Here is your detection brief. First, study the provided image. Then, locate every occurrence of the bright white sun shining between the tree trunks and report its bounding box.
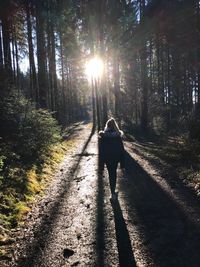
[86,57,103,79]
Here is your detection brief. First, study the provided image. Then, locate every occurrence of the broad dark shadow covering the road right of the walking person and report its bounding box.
[120,153,200,267]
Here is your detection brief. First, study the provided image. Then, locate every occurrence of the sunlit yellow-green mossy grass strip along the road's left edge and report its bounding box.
[0,129,75,265]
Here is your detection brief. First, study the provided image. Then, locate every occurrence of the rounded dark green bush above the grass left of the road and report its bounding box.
[0,92,60,160]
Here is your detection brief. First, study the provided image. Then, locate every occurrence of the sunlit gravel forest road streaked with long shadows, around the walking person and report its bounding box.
[10,124,200,267]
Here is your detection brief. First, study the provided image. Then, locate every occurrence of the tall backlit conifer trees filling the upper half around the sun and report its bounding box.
[0,0,200,137]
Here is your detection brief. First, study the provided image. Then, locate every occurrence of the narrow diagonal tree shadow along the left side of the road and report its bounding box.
[17,126,94,267]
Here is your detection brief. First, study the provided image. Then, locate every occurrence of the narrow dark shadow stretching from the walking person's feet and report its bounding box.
[111,200,136,267]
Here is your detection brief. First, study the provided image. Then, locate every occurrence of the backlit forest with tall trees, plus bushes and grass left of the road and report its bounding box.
[0,0,200,241]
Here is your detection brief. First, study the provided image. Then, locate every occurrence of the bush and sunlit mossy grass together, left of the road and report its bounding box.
[0,91,76,258]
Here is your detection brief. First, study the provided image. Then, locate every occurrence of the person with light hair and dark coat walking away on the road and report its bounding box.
[99,118,124,200]
